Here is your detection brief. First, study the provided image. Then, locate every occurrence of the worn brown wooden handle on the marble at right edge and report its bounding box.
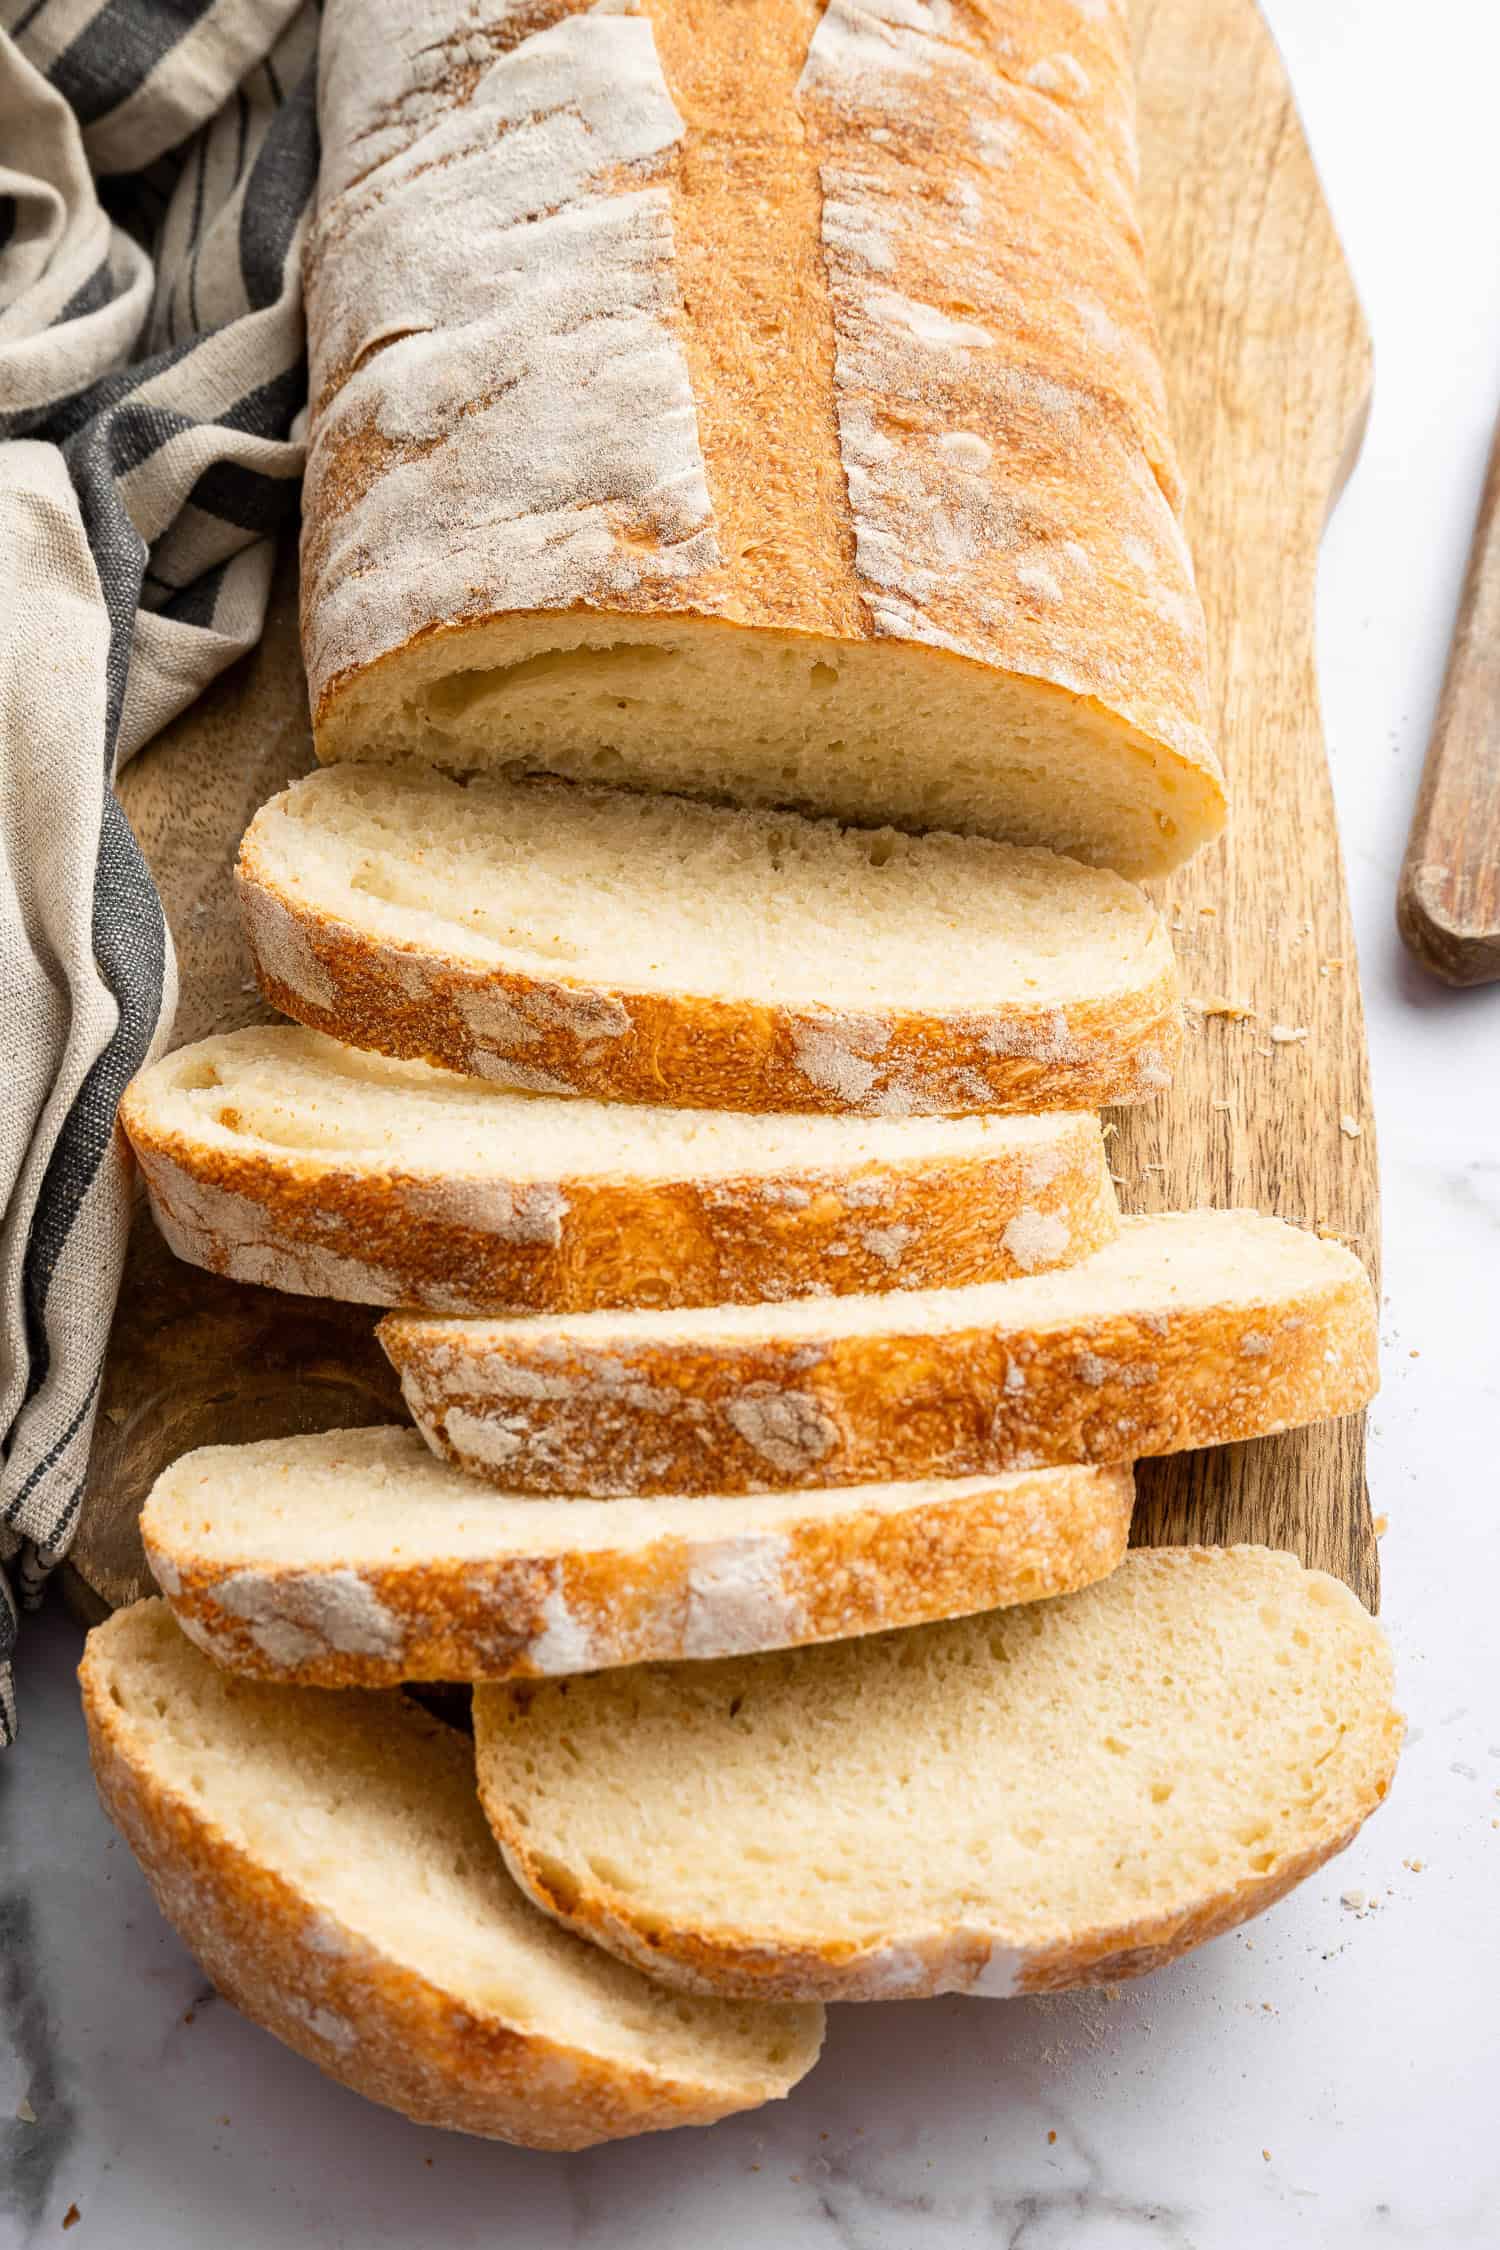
[1397,411,1500,986]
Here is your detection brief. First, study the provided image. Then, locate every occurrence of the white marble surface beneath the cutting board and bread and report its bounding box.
[0,0,1500,2250]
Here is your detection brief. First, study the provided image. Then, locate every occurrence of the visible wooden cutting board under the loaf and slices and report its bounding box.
[70,0,1379,1613]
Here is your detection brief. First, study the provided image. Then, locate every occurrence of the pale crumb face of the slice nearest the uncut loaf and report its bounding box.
[245,765,1172,1017]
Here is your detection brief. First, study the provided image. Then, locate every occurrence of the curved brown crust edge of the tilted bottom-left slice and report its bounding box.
[79,1647,823,2149]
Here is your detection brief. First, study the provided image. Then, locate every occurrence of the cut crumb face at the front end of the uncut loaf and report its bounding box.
[315,610,1226,880]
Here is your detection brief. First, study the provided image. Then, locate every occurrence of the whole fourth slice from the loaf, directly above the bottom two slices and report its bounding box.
[142,1429,1133,1688]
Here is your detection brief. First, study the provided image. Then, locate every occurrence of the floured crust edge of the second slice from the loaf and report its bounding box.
[121,1091,1120,1314]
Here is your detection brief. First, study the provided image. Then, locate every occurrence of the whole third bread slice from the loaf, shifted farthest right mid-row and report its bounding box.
[378,1211,1376,1496]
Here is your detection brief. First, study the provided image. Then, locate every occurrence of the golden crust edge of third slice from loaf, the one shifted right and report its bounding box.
[378,1260,1376,1496]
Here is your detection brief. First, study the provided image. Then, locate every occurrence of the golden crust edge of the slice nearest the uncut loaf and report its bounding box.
[236,850,1183,1116]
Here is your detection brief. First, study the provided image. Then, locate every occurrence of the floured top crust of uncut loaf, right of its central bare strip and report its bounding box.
[798,0,1212,765]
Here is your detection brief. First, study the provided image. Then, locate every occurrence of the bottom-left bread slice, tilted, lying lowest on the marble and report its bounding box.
[79,1602,823,2149]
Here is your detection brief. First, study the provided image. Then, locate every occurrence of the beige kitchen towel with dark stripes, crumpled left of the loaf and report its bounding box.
[0,0,317,1742]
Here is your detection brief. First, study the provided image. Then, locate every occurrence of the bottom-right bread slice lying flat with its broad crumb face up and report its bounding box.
[475,1548,1401,2000]
